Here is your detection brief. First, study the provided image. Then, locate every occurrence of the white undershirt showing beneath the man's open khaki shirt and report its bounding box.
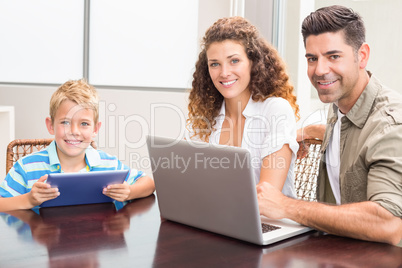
[325,109,345,205]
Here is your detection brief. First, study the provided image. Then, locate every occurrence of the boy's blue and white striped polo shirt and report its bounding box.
[0,141,145,197]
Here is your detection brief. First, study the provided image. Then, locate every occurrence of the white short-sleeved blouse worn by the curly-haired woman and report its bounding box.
[188,97,299,198]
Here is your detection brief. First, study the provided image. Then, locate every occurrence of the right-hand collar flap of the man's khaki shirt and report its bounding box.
[346,75,381,128]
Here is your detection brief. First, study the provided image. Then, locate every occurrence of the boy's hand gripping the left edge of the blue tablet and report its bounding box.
[28,175,60,207]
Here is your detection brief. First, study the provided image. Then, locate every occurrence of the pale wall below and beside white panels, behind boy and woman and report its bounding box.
[0,0,230,178]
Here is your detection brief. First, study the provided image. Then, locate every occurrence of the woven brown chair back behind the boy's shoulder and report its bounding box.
[6,139,53,174]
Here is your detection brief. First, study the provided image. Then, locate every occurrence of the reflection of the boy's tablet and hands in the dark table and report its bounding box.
[38,203,125,255]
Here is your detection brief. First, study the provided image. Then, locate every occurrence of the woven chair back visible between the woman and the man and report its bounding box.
[294,139,322,201]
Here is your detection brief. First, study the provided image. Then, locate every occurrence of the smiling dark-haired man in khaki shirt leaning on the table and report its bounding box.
[257,6,402,245]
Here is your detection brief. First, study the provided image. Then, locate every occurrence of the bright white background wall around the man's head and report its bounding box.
[283,0,402,130]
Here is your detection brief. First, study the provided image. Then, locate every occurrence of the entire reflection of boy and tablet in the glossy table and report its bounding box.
[3,196,155,267]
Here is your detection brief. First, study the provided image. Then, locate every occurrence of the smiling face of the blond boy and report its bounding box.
[46,100,100,161]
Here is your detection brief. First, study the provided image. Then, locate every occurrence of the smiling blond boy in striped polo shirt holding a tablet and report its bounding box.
[0,79,155,212]
